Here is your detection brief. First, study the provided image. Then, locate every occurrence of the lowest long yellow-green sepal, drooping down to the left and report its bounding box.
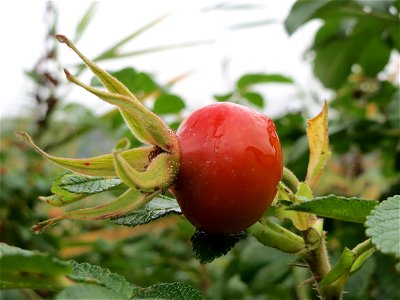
[31,189,158,233]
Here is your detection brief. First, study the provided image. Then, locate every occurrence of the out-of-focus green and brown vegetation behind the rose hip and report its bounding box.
[0,0,400,299]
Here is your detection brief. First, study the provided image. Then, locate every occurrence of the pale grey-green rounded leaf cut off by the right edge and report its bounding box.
[365,195,400,258]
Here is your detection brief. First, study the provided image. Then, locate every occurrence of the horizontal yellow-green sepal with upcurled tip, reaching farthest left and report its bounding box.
[17,131,153,177]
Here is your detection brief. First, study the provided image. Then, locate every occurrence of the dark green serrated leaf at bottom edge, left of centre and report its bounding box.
[133,282,204,300]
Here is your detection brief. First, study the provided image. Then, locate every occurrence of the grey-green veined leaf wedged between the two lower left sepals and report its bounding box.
[52,173,122,194]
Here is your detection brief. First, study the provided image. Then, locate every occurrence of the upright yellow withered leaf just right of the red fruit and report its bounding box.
[306,101,331,189]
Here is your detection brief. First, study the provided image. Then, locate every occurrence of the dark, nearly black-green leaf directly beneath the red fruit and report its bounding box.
[190,230,246,264]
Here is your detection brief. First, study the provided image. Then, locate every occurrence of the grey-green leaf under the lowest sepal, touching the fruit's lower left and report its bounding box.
[111,195,182,227]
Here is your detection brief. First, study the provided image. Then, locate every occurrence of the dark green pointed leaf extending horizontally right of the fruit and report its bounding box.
[287,195,378,223]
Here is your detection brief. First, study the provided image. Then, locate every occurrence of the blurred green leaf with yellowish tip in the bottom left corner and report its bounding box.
[0,243,72,291]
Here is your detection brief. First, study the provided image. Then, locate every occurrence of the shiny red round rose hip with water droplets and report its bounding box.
[172,102,283,234]
